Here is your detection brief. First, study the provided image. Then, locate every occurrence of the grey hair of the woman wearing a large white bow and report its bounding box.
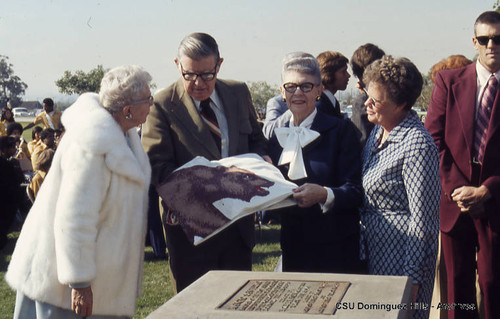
[281,52,321,85]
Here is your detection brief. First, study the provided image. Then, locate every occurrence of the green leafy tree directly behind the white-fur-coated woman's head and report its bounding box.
[56,65,108,94]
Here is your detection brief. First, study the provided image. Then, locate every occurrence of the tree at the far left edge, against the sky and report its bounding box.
[0,55,28,108]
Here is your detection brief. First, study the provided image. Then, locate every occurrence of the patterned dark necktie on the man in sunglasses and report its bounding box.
[474,75,498,164]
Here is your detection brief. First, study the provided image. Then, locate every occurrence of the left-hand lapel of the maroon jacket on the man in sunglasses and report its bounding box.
[451,63,477,154]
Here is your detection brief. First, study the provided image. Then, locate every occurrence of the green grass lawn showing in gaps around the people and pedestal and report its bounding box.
[0,226,281,319]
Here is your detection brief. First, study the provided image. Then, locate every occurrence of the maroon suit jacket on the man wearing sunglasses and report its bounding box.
[425,63,500,232]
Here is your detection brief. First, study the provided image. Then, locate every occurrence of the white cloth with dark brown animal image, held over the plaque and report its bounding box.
[158,154,296,245]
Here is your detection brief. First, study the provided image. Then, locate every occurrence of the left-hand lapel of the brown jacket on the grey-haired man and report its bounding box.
[169,79,221,159]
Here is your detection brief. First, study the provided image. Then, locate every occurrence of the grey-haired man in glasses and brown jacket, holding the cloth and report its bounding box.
[142,33,270,292]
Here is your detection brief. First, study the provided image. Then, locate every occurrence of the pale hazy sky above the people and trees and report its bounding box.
[0,0,494,101]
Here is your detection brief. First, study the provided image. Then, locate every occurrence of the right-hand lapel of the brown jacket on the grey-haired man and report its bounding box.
[214,80,242,156]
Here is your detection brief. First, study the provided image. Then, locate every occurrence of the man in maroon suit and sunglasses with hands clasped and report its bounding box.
[425,11,500,319]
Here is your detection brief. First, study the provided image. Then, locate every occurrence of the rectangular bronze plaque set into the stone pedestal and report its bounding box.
[217,279,351,315]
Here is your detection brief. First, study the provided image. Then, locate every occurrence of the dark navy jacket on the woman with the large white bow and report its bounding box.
[269,110,362,270]
